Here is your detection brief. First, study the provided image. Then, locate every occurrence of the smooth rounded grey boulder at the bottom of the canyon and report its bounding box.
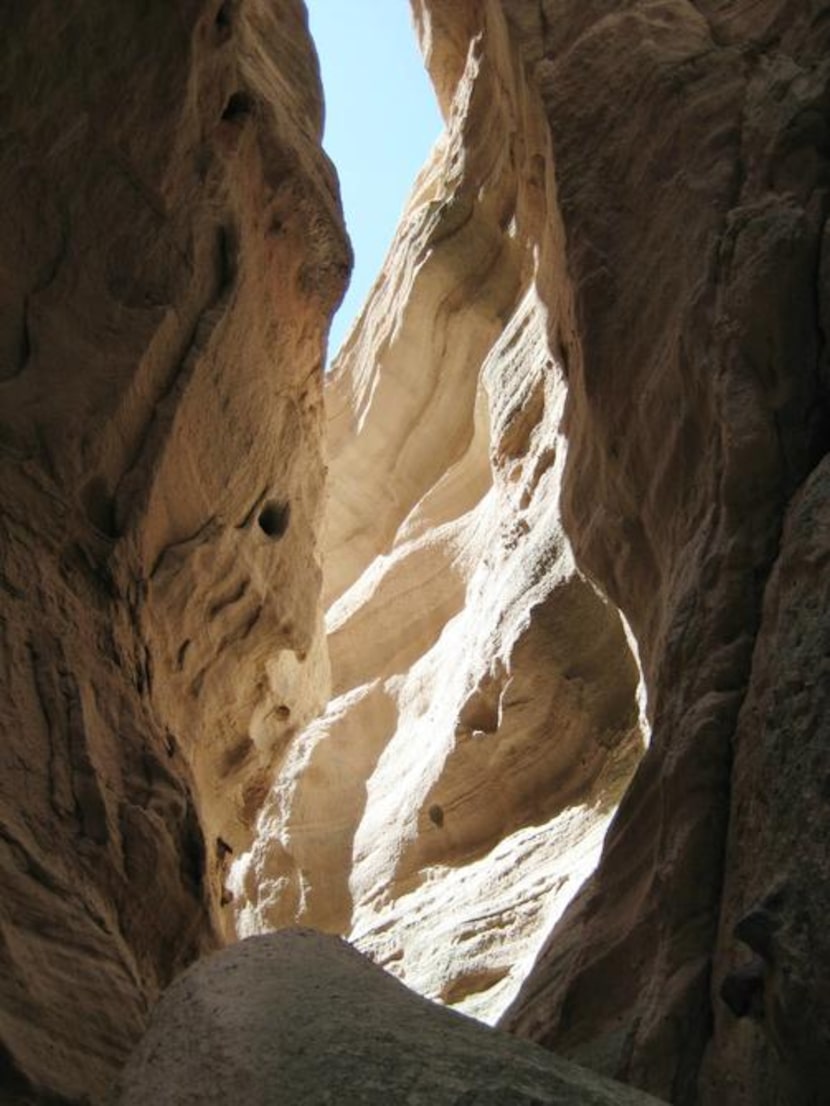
[116,930,657,1106]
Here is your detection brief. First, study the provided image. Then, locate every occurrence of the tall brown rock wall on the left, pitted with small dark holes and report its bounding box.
[0,0,349,1103]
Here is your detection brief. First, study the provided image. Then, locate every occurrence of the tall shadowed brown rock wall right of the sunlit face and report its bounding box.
[493,2,830,1104]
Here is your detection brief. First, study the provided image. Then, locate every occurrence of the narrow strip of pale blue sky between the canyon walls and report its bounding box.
[305,0,443,359]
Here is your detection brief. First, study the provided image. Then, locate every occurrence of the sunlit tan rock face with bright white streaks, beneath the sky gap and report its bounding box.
[229,4,644,1020]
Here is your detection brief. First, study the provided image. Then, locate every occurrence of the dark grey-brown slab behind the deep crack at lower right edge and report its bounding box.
[706,458,830,1106]
